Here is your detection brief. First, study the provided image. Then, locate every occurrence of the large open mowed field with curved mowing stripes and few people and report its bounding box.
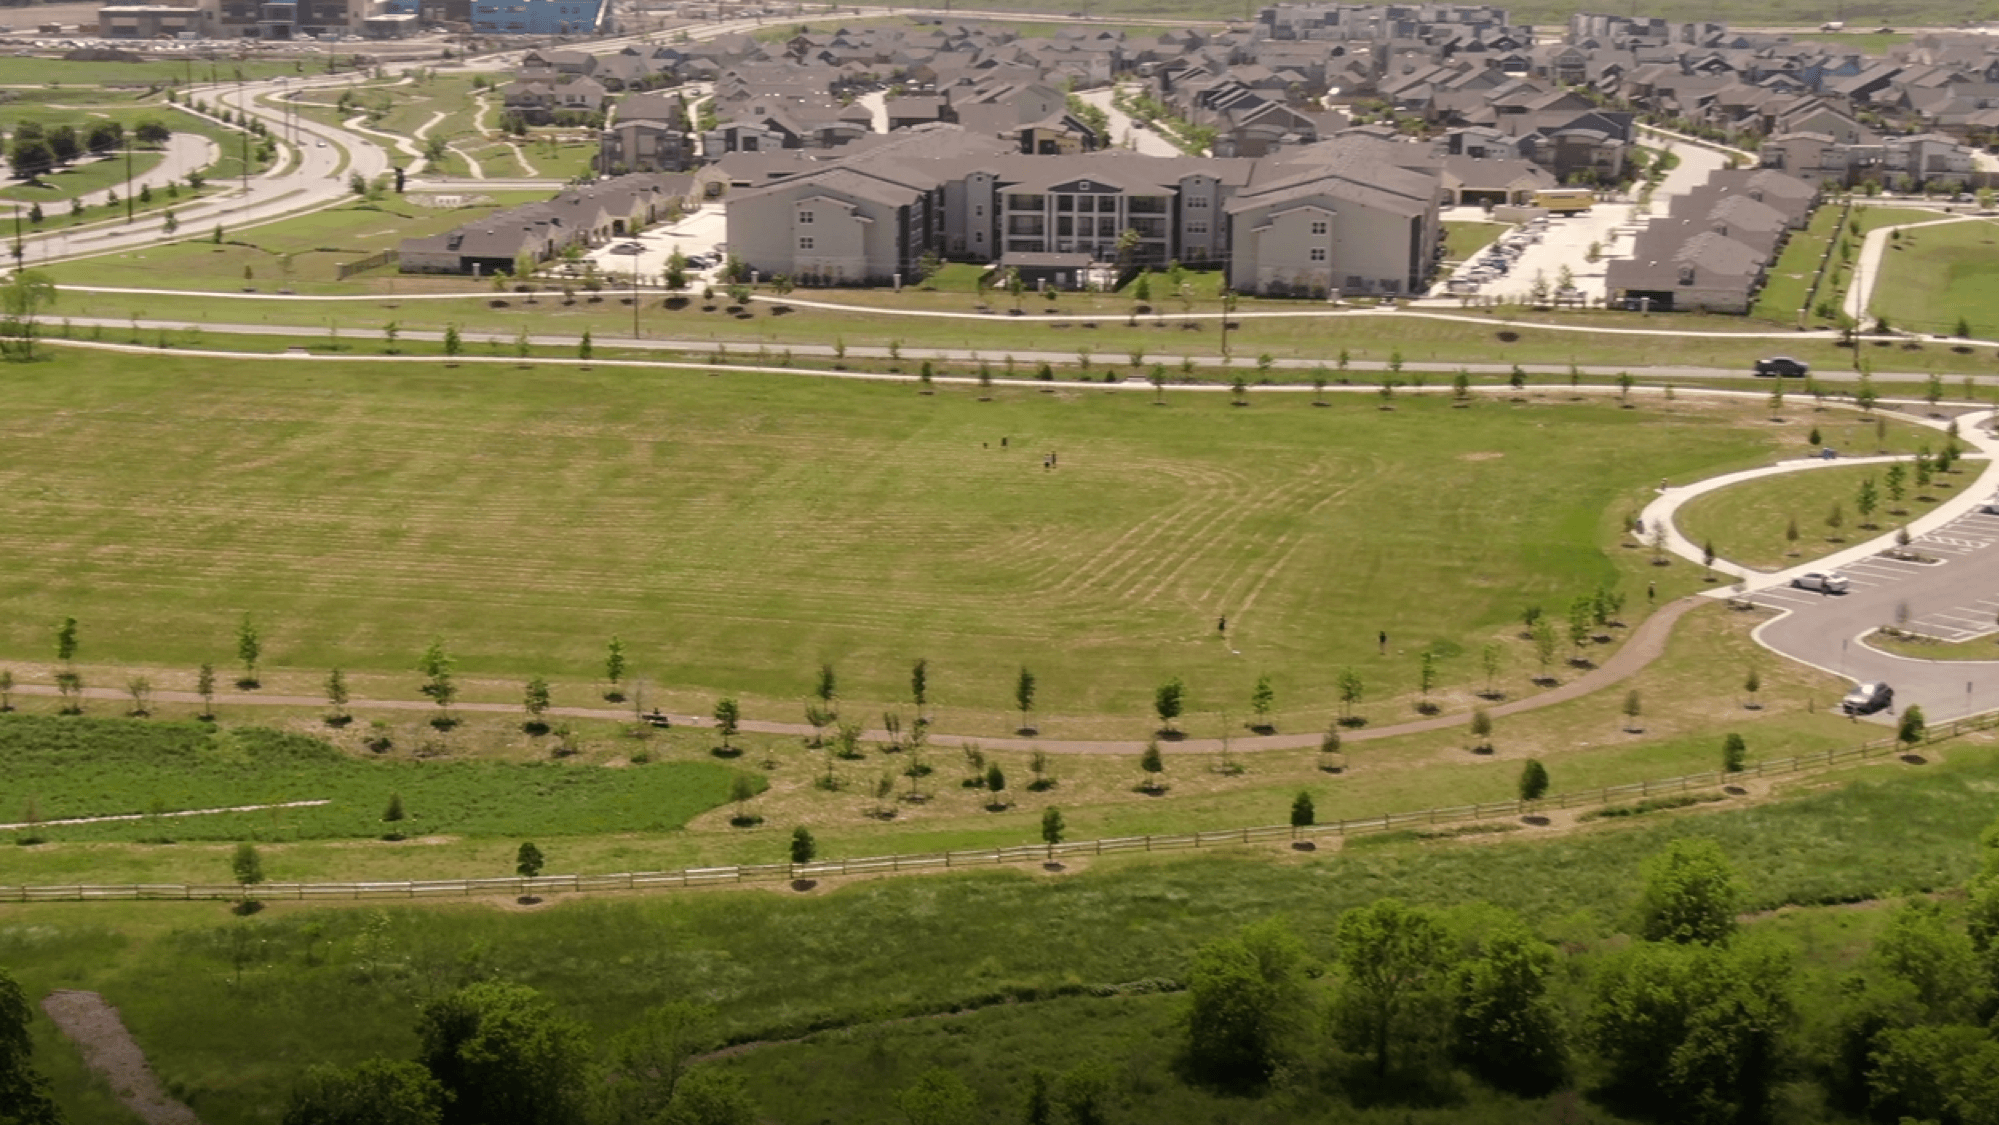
[0,348,1779,737]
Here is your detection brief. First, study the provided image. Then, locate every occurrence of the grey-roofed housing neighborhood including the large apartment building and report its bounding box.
[389,4,1999,312]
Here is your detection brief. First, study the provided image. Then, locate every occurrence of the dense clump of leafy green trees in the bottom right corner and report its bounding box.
[1185,825,1999,1125]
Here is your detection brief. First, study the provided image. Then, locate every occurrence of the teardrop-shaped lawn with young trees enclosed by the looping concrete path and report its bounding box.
[1677,451,1965,569]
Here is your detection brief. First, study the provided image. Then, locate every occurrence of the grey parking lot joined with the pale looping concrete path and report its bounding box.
[1641,405,1999,721]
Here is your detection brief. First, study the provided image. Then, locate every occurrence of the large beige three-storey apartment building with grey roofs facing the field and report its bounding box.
[728,126,1439,296]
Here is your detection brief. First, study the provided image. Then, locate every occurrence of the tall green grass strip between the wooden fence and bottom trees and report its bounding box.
[0,747,1999,1125]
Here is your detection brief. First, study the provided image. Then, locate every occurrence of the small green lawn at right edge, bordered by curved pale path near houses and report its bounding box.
[1873,220,1999,338]
